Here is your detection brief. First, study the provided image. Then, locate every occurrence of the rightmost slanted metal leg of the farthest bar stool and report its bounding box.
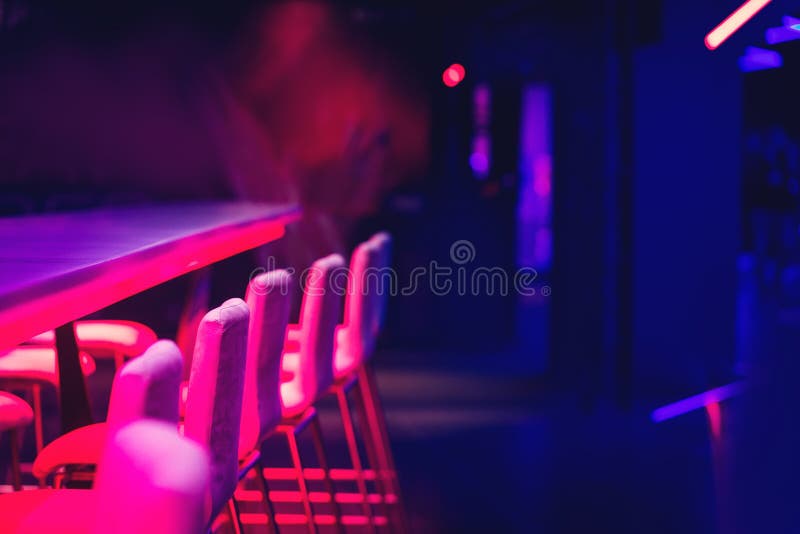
[358,363,411,532]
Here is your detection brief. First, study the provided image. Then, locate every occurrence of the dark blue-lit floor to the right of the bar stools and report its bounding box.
[370,354,716,532]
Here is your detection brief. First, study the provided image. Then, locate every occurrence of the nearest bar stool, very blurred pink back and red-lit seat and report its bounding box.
[0,420,210,534]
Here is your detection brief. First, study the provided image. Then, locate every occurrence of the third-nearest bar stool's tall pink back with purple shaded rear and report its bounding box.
[184,299,250,529]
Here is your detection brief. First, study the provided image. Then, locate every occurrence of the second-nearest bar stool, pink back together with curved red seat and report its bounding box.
[33,340,183,483]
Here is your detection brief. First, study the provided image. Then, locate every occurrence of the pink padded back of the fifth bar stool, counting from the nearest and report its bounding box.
[297,254,346,398]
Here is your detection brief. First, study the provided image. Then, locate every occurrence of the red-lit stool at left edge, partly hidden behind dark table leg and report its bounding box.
[0,346,96,453]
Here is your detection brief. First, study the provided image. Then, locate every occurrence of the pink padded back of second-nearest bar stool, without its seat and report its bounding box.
[108,340,183,429]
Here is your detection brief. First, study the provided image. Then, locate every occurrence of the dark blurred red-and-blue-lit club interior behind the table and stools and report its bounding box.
[0,0,800,533]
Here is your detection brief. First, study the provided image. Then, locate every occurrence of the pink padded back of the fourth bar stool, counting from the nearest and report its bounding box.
[239,270,292,458]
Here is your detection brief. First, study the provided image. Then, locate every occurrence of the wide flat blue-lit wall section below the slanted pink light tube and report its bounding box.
[634,0,742,398]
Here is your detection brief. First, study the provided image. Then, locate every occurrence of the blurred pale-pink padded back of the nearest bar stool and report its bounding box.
[92,420,209,534]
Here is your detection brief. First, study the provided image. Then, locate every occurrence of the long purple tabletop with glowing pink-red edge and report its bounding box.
[0,202,300,350]
